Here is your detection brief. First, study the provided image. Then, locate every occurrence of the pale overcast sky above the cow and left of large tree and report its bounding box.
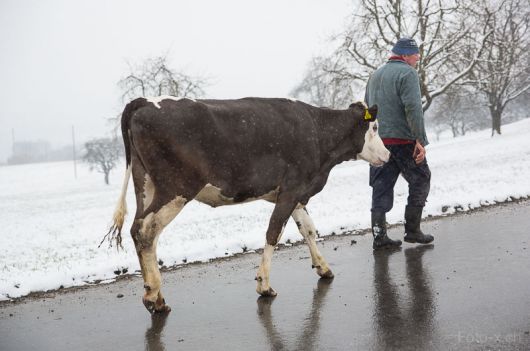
[0,0,353,162]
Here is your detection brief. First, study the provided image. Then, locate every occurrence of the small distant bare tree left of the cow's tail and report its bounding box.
[83,138,123,185]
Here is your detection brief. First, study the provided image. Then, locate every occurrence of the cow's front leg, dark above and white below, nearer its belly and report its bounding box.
[256,194,297,296]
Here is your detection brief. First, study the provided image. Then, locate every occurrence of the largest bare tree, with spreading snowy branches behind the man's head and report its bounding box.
[302,0,490,111]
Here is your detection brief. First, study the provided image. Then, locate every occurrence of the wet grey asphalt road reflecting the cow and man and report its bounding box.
[0,201,530,350]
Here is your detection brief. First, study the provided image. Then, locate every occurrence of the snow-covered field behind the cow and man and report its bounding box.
[0,119,530,300]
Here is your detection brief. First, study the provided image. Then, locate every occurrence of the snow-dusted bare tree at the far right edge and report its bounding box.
[473,0,530,136]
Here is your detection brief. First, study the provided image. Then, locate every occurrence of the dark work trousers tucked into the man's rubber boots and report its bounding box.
[370,144,431,213]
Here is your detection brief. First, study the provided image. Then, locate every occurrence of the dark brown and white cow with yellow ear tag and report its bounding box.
[106,96,389,313]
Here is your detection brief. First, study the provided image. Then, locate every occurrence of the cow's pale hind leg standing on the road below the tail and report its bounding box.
[131,195,187,313]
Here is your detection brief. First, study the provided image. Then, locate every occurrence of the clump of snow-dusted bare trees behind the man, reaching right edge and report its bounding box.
[292,0,530,135]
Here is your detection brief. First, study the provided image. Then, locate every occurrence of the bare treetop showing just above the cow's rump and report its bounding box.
[118,56,207,101]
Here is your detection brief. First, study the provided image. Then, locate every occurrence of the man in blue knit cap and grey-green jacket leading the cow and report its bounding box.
[365,38,434,250]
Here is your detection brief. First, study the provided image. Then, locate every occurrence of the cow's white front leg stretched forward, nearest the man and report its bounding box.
[292,205,333,279]
